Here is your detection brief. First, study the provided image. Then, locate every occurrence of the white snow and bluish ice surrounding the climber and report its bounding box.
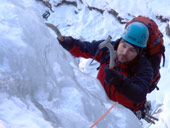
[0,0,170,128]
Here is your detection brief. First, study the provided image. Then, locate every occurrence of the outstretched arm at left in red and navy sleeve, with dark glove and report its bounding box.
[58,36,106,61]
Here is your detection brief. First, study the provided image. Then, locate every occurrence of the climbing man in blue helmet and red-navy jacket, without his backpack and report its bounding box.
[56,22,153,112]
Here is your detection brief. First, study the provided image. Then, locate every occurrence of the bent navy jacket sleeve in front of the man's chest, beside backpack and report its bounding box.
[116,55,153,103]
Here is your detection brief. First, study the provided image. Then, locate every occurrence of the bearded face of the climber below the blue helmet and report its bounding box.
[117,39,137,64]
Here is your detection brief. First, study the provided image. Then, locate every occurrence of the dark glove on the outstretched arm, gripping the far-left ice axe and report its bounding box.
[57,36,74,51]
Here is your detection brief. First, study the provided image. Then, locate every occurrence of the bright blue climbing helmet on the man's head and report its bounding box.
[122,22,149,48]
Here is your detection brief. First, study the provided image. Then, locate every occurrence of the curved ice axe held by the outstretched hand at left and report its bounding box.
[45,23,64,41]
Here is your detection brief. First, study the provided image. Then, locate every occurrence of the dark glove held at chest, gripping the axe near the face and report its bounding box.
[104,66,124,87]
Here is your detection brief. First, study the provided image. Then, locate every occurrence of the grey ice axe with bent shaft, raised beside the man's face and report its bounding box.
[90,35,116,69]
